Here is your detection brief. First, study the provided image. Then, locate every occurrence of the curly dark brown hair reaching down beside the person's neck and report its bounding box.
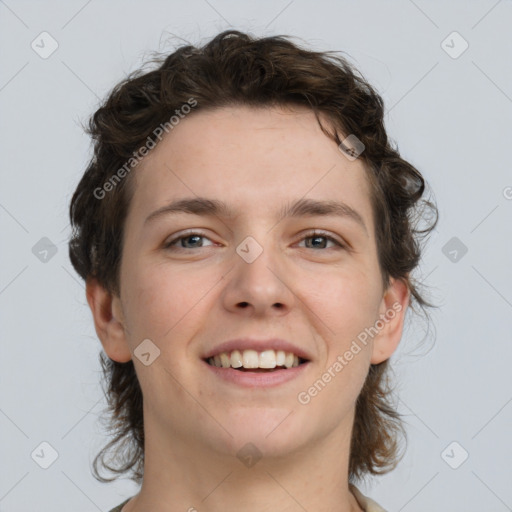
[69,30,438,483]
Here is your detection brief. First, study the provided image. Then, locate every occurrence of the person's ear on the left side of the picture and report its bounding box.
[85,278,132,363]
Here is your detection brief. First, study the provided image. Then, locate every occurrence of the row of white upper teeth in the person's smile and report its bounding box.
[208,350,299,368]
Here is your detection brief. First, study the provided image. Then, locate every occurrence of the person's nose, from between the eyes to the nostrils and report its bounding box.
[222,239,296,316]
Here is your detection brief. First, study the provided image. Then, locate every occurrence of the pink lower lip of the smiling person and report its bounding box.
[203,361,309,388]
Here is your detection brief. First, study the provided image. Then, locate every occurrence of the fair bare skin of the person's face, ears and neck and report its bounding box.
[87,106,409,512]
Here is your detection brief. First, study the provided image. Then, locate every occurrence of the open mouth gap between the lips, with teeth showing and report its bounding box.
[204,350,308,373]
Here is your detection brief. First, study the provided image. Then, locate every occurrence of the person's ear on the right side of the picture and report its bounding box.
[371,279,410,364]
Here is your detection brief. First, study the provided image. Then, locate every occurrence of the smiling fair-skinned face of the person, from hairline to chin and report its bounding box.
[94,107,406,455]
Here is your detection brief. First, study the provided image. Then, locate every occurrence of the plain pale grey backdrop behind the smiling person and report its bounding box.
[0,0,512,512]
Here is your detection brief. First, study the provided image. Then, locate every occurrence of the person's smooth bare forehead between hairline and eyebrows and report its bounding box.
[125,106,372,229]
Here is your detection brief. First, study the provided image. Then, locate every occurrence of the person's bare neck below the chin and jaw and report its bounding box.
[123,408,362,512]
